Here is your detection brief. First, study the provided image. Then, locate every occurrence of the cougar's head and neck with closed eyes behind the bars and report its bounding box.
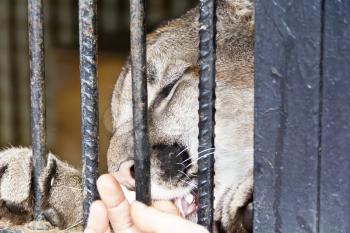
[107,0,254,232]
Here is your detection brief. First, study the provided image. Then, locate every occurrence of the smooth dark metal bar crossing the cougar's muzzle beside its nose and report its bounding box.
[130,0,151,204]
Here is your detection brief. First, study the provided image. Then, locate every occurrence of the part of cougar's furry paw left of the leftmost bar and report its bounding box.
[0,148,33,228]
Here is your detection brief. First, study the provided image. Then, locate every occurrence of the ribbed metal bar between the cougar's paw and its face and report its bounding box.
[79,0,98,227]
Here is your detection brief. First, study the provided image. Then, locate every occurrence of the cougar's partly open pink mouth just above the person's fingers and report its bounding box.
[172,190,198,220]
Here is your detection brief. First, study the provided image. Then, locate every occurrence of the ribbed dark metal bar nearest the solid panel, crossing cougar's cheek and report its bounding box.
[198,0,216,231]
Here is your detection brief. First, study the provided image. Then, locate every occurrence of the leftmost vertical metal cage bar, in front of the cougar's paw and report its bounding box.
[28,0,46,220]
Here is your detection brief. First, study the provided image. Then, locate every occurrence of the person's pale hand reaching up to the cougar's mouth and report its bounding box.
[85,174,208,233]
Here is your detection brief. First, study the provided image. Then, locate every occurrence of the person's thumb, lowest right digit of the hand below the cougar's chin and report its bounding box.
[131,201,208,233]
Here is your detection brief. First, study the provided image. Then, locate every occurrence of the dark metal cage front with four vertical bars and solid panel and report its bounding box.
[1,0,350,233]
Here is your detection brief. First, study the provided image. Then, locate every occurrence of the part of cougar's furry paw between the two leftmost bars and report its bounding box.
[40,154,83,229]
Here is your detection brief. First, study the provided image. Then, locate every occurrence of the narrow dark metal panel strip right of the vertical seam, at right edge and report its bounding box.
[320,1,350,233]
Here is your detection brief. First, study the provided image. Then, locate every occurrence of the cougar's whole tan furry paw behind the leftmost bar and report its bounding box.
[0,148,82,229]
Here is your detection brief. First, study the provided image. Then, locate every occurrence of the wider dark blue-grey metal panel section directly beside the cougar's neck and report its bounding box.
[254,0,322,233]
